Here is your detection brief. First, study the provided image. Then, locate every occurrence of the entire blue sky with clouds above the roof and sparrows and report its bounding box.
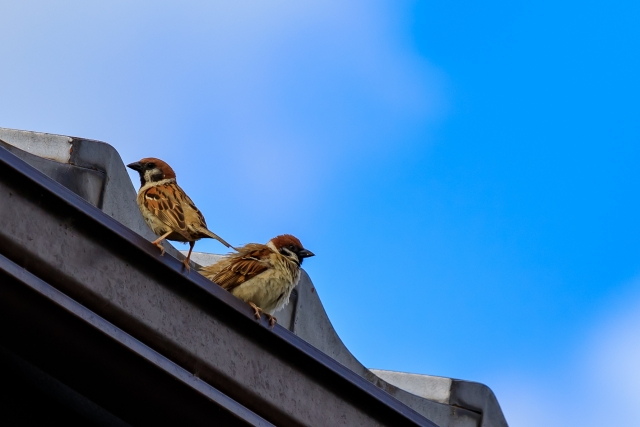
[0,0,640,427]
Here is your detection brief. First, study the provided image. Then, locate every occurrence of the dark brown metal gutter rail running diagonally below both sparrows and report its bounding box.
[0,143,436,427]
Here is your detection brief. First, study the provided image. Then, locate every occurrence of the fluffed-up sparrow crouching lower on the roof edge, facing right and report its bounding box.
[200,234,314,327]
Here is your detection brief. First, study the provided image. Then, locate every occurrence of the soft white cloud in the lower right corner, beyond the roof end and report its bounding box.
[494,279,640,427]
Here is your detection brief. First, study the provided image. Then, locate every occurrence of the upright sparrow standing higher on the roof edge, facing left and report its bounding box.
[127,157,234,272]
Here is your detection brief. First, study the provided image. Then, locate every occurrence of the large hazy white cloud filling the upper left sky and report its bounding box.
[0,0,444,217]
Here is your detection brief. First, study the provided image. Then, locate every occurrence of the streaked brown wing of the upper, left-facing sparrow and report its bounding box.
[144,184,187,234]
